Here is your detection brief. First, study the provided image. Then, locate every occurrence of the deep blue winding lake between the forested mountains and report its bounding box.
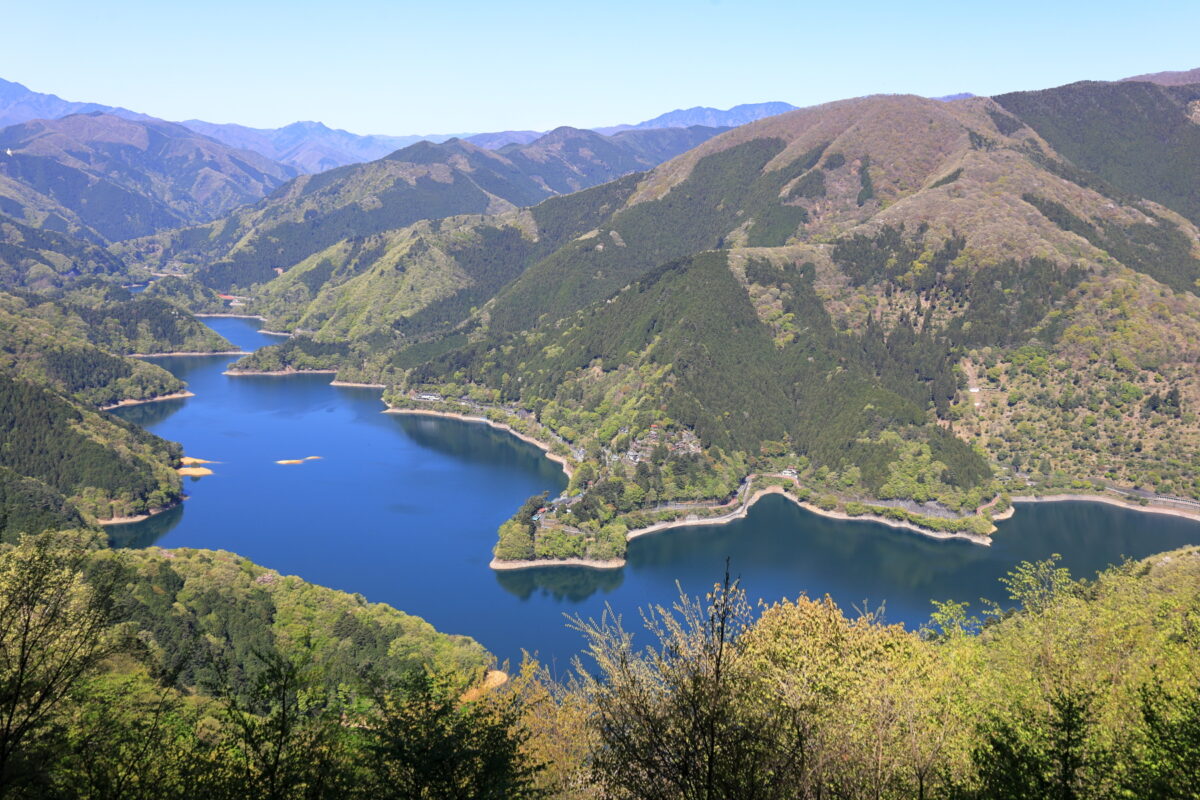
[109,318,1200,670]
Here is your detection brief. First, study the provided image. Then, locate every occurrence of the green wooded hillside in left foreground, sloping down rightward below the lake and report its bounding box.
[0,527,496,800]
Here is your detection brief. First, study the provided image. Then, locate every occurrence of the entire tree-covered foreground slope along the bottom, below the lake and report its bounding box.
[0,534,1200,800]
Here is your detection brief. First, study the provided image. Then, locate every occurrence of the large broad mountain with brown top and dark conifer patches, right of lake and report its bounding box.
[223,84,1200,558]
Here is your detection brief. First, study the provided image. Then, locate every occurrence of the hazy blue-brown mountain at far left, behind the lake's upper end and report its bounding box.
[0,112,295,242]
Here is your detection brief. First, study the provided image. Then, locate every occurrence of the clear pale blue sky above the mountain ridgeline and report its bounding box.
[0,0,1200,134]
